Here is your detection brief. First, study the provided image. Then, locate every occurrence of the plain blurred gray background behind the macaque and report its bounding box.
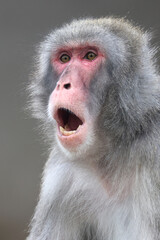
[0,0,160,240]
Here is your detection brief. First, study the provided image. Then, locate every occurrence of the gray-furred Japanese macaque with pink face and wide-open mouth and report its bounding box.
[27,18,160,240]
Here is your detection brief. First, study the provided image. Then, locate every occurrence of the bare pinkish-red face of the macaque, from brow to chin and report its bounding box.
[49,46,105,149]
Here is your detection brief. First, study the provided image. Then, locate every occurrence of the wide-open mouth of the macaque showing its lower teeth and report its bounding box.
[57,108,83,136]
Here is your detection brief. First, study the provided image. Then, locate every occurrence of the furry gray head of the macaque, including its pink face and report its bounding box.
[31,18,155,152]
